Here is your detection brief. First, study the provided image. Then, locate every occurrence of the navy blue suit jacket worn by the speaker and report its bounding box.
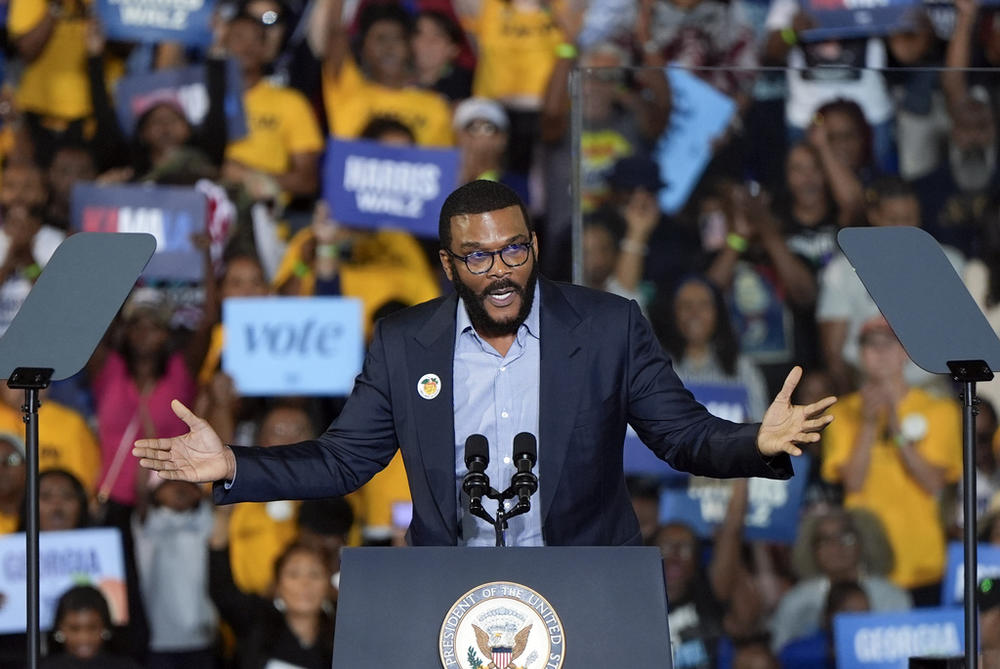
[215,278,792,546]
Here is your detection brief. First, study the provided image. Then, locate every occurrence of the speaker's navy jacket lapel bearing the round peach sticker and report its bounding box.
[406,293,458,544]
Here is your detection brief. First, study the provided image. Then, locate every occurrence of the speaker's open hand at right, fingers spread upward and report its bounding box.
[757,366,837,456]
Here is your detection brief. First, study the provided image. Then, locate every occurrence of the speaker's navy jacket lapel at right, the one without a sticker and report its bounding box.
[538,278,587,527]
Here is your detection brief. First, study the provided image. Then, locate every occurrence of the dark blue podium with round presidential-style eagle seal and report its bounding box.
[333,546,671,669]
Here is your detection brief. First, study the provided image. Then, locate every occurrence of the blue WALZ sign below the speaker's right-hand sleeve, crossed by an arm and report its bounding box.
[660,455,810,544]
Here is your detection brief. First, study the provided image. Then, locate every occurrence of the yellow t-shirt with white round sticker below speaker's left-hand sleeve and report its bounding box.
[229,502,299,596]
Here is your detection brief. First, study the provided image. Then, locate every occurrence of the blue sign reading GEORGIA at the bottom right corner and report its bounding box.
[833,608,965,669]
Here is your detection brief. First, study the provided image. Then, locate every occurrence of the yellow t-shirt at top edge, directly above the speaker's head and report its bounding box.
[466,0,566,107]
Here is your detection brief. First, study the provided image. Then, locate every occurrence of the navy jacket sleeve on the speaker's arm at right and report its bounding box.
[626,302,792,479]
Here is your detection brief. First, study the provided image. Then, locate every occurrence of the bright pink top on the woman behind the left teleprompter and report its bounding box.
[93,352,197,505]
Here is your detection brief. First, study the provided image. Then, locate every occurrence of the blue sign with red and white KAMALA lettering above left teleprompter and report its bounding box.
[70,182,208,281]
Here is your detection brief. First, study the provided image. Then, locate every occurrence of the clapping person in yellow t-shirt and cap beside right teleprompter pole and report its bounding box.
[823,316,962,606]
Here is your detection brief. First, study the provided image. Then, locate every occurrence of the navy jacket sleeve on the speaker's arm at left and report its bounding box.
[214,324,399,504]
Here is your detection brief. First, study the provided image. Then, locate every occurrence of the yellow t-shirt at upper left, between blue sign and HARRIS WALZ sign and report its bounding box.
[226,79,323,174]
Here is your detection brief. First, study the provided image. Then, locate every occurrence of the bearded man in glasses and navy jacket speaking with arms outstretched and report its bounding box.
[133,181,835,546]
